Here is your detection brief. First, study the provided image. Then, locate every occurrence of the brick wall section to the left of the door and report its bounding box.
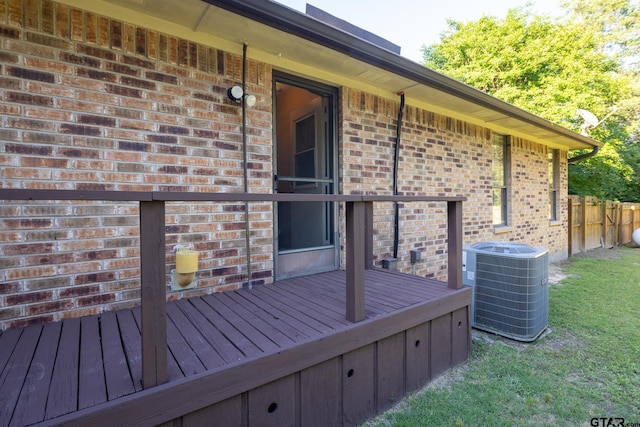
[0,0,273,329]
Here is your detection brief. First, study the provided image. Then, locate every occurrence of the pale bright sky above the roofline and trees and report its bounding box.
[274,0,560,62]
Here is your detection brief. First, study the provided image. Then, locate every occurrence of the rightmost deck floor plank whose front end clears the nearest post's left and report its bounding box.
[100,312,135,400]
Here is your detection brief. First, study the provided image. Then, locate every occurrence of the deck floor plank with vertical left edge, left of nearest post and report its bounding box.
[78,316,107,409]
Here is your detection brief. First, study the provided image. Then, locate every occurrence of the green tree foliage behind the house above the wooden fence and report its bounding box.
[423,0,640,201]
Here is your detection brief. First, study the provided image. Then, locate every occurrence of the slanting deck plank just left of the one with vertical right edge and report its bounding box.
[10,322,62,426]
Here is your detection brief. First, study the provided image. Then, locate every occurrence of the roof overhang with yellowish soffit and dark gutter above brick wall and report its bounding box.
[58,0,602,150]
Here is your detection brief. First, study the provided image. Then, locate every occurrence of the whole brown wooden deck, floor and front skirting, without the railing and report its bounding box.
[0,269,471,426]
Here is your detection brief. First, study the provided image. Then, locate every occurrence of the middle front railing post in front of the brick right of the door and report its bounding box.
[345,202,370,323]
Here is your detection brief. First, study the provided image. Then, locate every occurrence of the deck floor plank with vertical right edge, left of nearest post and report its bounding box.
[46,318,80,418]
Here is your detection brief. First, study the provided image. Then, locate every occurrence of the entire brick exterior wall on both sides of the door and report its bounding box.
[0,0,567,329]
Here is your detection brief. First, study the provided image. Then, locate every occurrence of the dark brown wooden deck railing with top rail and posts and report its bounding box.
[0,189,465,388]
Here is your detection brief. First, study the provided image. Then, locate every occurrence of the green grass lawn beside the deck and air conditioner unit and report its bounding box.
[366,247,640,426]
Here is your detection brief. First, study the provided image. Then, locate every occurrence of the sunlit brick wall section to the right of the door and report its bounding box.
[340,89,567,280]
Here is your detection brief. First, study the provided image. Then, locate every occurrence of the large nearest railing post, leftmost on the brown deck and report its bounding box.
[140,201,169,388]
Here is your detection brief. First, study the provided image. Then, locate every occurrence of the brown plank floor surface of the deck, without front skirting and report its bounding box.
[0,270,470,427]
